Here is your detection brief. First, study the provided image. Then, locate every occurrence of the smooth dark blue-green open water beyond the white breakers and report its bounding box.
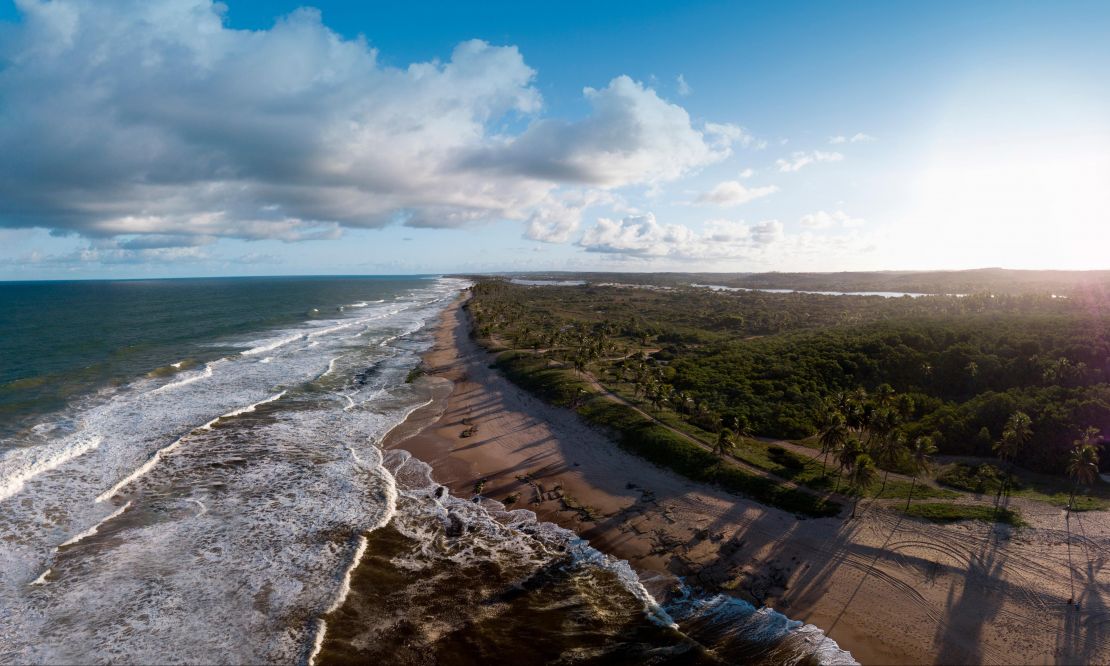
[0,276,428,438]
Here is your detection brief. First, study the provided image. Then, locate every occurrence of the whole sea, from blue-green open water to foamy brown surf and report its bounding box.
[0,276,852,664]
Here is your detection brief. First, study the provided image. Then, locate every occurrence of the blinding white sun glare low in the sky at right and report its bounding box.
[904,127,1110,269]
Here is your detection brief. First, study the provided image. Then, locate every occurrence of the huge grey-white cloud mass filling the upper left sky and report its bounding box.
[0,0,744,246]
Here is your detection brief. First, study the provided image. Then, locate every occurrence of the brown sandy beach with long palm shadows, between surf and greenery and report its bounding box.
[375,303,1110,664]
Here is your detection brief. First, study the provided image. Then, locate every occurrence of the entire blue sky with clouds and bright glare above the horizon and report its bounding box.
[0,0,1110,280]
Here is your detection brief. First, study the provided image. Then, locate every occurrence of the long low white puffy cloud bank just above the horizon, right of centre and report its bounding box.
[578,213,783,261]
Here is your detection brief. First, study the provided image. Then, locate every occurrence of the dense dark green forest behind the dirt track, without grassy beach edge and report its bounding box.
[474,280,1110,474]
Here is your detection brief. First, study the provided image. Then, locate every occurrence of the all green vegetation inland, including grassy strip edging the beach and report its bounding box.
[470,276,1110,523]
